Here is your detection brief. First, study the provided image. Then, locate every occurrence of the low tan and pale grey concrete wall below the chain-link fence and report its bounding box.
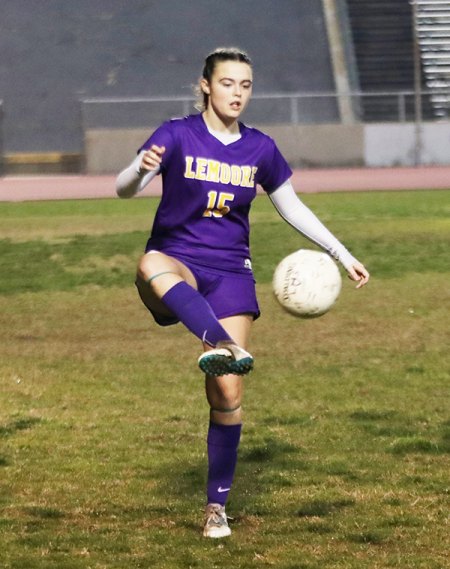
[85,122,450,174]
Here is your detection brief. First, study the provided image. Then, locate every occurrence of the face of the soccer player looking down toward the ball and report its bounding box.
[202,61,253,124]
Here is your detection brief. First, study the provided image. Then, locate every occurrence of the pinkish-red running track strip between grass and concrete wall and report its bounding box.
[0,166,450,202]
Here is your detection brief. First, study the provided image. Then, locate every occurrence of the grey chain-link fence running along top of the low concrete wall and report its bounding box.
[81,89,450,130]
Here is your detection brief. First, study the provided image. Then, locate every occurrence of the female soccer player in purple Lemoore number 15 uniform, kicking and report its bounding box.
[117,48,369,538]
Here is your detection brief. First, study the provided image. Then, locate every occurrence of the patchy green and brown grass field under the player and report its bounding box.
[0,191,450,569]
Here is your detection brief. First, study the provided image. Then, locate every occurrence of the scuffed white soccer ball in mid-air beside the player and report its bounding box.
[273,249,342,318]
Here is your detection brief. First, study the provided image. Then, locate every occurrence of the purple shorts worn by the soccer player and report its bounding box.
[136,259,261,326]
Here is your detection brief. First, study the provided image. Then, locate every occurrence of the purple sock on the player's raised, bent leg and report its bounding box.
[161,281,232,347]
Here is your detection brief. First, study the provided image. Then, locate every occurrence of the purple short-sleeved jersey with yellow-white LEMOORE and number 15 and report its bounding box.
[140,114,292,276]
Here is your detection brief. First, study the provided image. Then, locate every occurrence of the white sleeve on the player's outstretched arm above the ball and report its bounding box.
[269,180,356,269]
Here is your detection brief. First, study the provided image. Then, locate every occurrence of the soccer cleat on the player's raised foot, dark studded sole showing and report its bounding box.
[198,342,253,376]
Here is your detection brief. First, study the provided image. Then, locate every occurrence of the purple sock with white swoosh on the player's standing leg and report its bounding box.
[207,422,242,506]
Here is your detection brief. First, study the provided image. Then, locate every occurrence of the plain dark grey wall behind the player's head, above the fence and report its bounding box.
[0,0,334,153]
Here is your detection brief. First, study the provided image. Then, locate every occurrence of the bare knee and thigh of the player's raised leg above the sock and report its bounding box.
[136,251,197,316]
